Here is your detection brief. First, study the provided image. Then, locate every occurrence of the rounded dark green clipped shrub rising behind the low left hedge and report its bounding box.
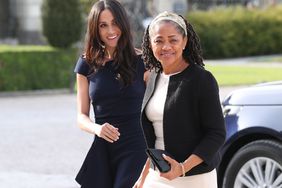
[42,0,83,48]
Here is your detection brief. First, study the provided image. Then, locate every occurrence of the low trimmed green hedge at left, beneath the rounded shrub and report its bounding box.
[0,47,77,91]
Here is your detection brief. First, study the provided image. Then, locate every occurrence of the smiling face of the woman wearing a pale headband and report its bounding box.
[150,21,187,72]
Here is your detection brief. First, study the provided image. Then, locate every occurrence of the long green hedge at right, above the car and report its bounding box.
[187,6,282,59]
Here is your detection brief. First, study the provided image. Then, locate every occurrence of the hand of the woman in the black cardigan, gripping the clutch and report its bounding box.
[160,154,182,180]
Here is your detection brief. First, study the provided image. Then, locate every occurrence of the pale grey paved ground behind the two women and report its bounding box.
[0,87,242,188]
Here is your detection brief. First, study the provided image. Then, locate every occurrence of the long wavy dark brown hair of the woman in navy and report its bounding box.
[84,0,136,85]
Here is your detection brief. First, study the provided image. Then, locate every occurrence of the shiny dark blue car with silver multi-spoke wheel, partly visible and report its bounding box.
[218,81,282,188]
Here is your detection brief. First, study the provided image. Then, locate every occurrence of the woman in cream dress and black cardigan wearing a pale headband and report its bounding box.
[134,12,226,188]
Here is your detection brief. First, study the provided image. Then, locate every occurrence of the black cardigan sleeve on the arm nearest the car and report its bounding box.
[193,71,226,164]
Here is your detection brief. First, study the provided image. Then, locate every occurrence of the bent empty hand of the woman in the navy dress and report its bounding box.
[94,123,120,143]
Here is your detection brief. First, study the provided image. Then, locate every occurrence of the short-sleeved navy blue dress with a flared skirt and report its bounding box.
[74,56,147,188]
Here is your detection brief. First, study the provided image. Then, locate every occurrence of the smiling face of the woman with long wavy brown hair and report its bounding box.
[98,9,121,54]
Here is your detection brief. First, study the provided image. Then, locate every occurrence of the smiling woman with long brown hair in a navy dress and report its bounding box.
[72,0,146,188]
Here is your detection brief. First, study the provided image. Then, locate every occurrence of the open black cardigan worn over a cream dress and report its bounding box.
[141,64,226,176]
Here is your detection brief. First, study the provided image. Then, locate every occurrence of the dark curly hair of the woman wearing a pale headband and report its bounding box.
[142,15,205,72]
